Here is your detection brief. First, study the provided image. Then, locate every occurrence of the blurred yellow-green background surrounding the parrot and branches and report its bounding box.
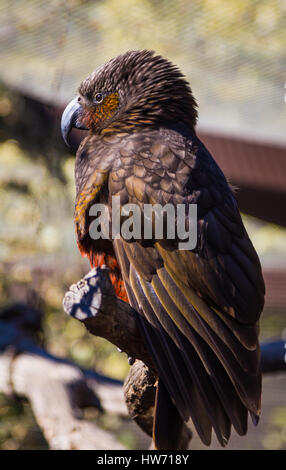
[0,0,286,449]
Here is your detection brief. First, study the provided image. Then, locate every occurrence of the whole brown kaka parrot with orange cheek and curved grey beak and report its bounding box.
[61,51,265,449]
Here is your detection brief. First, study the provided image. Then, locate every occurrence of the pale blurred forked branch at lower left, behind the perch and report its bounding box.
[0,305,126,450]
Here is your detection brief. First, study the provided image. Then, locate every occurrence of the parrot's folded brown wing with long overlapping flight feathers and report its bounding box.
[107,129,265,445]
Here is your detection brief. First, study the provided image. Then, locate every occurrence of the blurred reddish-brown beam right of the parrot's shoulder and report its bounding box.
[199,132,286,227]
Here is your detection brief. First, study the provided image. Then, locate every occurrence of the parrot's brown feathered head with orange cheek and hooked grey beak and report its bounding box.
[62,51,197,143]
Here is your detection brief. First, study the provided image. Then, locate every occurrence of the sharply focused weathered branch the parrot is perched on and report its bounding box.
[63,268,285,449]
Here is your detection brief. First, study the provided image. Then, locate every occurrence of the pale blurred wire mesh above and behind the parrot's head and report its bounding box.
[0,0,286,143]
